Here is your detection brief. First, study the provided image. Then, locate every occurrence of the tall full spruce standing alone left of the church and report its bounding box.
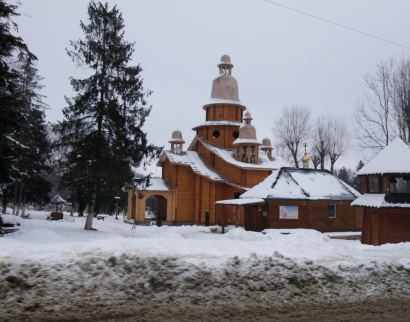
[54,1,160,229]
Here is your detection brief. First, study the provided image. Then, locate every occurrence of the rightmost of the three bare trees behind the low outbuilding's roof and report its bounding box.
[327,116,350,173]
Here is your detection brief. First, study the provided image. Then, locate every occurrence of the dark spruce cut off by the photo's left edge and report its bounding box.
[0,0,41,211]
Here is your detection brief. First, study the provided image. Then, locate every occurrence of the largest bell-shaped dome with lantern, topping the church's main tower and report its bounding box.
[211,55,240,103]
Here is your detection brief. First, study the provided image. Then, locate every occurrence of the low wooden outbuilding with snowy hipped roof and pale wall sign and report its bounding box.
[229,167,362,232]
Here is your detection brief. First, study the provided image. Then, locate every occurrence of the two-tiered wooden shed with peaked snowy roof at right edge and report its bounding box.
[352,138,410,246]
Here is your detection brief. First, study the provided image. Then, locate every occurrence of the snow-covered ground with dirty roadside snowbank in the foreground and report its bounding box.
[0,211,410,321]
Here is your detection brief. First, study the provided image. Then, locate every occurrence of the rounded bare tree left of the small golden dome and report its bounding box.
[272,105,311,168]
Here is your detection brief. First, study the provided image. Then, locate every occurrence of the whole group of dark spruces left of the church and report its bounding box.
[0,0,161,229]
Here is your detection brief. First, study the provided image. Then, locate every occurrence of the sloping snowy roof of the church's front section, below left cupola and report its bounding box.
[157,150,249,190]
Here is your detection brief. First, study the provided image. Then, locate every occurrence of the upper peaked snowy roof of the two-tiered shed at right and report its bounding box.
[357,137,410,175]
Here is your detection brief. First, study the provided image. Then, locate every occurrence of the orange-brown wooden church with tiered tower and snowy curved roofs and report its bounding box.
[126,55,289,225]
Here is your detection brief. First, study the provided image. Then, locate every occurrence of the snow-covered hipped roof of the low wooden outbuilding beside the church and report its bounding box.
[240,168,360,200]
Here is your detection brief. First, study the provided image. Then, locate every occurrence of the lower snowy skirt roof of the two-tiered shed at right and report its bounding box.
[351,193,410,208]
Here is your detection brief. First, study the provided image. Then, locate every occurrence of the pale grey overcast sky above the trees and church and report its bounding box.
[13,0,410,174]
